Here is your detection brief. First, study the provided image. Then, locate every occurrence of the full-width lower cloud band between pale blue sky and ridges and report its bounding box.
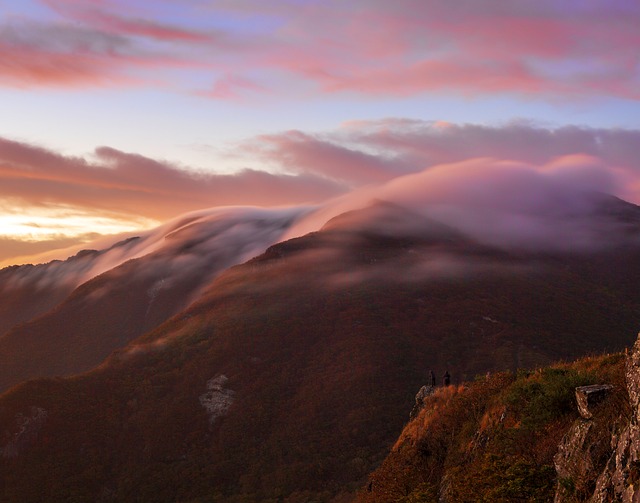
[8,119,640,219]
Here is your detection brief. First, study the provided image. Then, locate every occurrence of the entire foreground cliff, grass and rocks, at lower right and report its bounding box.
[357,338,640,503]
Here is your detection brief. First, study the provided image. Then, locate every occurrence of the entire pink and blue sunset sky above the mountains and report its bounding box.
[0,0,640,265]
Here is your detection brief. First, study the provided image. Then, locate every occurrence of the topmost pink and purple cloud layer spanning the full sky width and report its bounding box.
[0,0,640,100]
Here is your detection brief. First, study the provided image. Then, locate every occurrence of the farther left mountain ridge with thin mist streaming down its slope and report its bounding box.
[0,208,306,390]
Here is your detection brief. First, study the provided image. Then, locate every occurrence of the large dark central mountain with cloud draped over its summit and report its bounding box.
[0,198,640,502]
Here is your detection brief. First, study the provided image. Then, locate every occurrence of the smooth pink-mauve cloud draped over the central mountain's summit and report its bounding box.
[289,156,637,251]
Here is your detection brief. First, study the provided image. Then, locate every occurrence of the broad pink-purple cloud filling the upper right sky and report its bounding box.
[190,0,640,99]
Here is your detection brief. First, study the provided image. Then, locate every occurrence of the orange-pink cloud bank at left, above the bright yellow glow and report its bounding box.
[0,139,345,219]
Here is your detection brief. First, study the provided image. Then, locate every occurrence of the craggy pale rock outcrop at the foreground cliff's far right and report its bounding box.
[554,336,640,503]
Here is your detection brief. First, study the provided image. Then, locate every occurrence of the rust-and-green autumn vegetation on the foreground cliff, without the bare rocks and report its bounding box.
[358,354,629,503]
